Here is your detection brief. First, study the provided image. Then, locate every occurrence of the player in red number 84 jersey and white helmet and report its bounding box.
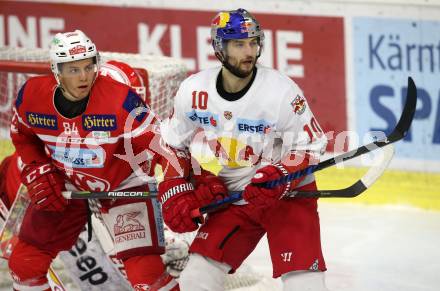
[9,30,186,290]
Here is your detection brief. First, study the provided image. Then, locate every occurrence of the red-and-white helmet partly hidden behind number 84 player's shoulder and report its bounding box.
[99,61,147,102]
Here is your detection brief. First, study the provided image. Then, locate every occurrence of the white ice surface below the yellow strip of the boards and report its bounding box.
[0,202,440,291]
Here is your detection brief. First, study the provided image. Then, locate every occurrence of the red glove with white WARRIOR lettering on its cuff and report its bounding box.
[159,178,200,233]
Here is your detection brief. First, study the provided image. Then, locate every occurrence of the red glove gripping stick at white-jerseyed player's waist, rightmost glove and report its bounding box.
[243,164,290,210]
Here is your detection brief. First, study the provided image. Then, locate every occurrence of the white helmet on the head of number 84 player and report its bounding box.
[49,29,99,76]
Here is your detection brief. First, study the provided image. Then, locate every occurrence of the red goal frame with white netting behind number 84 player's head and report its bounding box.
[0,47,188,141]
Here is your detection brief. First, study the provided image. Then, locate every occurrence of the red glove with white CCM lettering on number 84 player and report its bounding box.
[21,163,68,211]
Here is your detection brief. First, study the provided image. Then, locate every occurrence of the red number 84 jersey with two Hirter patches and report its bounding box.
[11,76,160,191]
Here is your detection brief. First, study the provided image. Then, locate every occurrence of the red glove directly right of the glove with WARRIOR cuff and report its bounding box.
[193,170,228,207]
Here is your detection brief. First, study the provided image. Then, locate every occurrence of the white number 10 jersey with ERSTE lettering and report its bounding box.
[161,65,327,191]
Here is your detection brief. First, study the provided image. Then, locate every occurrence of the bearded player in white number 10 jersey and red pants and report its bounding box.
[159,9,327,291]
